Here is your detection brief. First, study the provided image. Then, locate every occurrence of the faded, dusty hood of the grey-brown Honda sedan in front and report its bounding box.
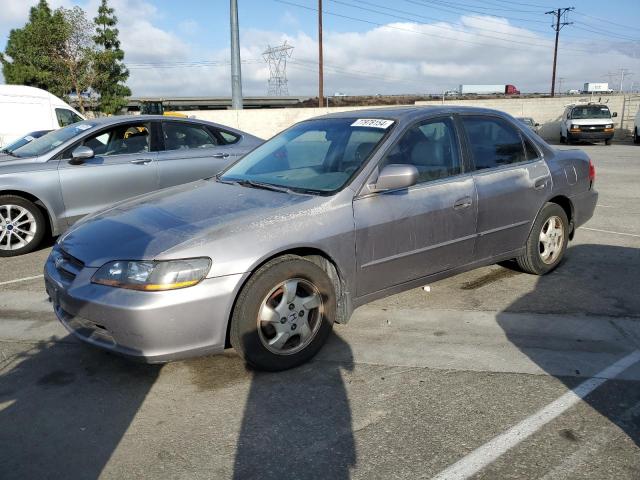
[59,180,327,267]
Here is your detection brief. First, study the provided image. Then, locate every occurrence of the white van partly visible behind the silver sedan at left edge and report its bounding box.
[0,85,85,148]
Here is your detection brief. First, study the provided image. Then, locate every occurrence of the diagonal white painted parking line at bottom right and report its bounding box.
[433,350,640,480]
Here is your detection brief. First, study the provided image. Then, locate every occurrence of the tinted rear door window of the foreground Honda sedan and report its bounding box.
[461,116,527,170]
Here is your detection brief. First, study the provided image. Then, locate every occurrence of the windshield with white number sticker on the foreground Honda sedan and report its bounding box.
[219,118,393,193]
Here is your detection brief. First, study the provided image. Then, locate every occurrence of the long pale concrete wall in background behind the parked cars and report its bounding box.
[182,95,631,141]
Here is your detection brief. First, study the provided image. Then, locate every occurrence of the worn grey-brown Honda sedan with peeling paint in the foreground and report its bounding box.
[45,107,597,370]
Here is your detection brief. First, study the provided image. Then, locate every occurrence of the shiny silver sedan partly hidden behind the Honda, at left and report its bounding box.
[0,115,262,257]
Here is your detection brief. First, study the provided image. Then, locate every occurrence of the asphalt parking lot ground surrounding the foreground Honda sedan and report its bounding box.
[0,144,640,480]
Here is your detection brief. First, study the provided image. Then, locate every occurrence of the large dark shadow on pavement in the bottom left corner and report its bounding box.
[0,336,161,480]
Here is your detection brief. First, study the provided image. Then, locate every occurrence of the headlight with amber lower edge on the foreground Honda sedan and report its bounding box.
[91,258,211,292]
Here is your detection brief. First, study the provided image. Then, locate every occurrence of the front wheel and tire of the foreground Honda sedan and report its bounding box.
[230,255,336,371]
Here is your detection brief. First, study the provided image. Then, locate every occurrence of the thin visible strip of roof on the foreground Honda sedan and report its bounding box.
[315,105,507,122]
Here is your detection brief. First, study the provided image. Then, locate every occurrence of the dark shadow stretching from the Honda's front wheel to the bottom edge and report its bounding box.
[233,333,356,480]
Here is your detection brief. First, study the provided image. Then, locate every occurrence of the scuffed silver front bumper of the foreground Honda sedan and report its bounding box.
[44,253,244,363]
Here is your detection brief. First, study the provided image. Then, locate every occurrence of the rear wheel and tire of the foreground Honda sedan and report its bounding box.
[516,203,569,275]
